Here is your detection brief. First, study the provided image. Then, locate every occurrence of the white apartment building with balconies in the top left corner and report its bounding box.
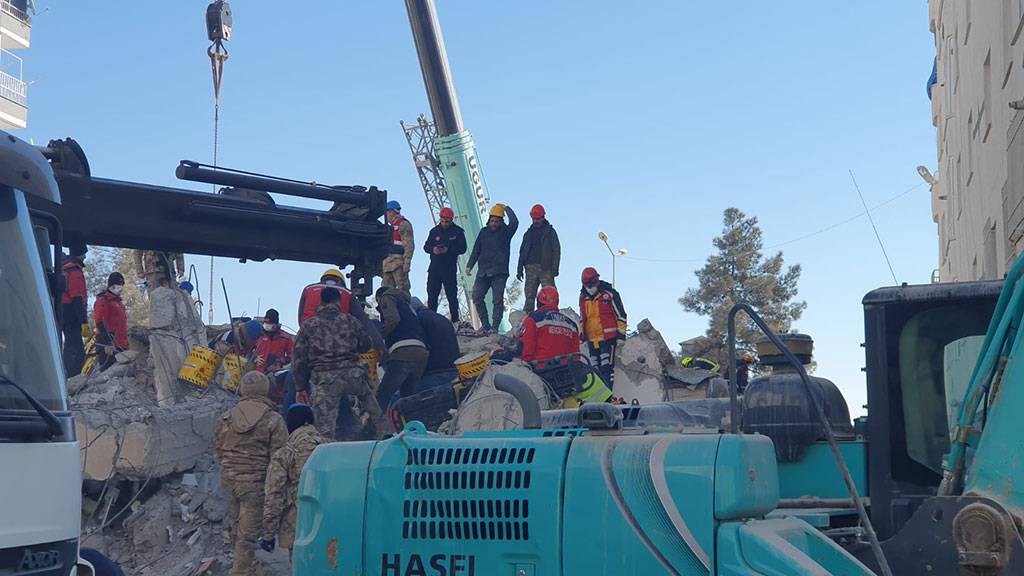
[0,0,32,130]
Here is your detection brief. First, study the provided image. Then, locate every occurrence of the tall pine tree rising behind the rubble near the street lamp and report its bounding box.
[679,208,807,366]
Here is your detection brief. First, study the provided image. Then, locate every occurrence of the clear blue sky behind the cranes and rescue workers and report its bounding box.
[19,0,937,412]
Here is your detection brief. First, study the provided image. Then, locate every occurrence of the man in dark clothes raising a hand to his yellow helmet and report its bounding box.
[466,204,519,333]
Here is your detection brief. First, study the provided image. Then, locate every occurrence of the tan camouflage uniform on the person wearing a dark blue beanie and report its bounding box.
[263,424,327,549]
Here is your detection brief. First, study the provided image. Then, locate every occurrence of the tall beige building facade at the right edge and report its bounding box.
[928,0,1024,282]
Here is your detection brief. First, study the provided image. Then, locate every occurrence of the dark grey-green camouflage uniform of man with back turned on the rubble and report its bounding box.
[292,304,381,439]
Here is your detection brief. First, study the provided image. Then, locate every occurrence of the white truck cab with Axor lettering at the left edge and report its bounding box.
[0,132,86,576]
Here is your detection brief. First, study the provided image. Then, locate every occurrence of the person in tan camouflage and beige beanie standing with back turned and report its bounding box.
[213,370,288,576]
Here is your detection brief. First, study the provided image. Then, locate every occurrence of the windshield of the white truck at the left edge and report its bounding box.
[0,188,68,411]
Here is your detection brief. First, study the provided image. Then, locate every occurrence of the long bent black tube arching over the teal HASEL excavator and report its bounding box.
[728,303,893,576]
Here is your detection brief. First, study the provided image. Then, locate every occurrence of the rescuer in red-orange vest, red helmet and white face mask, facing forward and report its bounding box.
[580,268,626,387]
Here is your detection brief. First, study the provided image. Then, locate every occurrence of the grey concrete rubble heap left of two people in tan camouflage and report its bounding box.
[69,328,291,576]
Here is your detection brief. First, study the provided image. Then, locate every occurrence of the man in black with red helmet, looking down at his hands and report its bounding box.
[423,206,466,324]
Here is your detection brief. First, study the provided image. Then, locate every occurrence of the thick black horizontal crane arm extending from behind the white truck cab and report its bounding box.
[24,138,390,294]
